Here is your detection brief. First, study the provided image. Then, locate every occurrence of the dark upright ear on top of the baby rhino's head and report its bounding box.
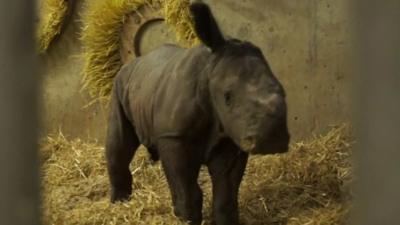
[190,1,225,51]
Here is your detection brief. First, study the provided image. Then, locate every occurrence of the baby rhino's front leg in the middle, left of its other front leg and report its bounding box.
[159,140,203,225]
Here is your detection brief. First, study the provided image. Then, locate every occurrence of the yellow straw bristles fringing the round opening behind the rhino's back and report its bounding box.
[81,0,195,100]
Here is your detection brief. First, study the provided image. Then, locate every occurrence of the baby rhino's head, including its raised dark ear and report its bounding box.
[190,2,290,154]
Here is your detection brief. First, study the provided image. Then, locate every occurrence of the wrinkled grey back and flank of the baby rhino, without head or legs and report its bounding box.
[123,45,208,146]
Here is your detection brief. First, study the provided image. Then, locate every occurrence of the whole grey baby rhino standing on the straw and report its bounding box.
[106,3,289,225]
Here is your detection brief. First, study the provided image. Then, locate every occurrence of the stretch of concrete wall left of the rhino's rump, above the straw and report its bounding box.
[42,1,107,139]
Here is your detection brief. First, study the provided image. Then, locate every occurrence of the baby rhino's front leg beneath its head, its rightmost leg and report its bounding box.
[207,139,248,225]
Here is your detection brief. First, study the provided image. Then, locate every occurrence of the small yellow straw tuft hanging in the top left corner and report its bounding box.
[36,0,68,53]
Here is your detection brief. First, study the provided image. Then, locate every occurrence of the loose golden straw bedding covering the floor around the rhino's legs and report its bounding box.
[42,126,353,225]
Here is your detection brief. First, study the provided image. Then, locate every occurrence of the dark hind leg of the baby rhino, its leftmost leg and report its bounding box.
[106,91,139,202]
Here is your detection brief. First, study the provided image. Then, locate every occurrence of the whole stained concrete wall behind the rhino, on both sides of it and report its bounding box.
[44,0,351,139]
